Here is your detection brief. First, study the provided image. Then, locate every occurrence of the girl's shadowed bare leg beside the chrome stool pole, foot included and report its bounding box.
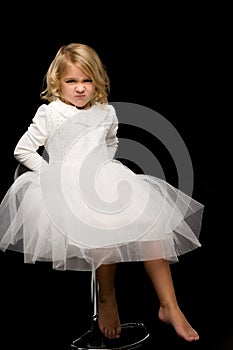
[96,264,121,339]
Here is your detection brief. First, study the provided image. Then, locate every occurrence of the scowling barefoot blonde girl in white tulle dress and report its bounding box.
[0,43,203,341]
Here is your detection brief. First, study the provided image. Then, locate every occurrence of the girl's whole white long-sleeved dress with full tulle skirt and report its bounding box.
[0,100,203,270]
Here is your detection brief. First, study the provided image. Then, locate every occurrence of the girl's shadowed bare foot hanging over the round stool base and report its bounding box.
[98,296,121,339]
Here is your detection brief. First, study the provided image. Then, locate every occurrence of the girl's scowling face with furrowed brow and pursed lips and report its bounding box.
[61,63,95,109]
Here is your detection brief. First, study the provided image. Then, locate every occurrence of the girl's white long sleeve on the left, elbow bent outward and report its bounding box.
[14,104,48,171]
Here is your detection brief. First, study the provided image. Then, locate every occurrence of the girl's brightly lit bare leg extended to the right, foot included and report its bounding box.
[144,259,199,341]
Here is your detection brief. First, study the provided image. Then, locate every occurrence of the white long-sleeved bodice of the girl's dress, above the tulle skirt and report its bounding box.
[14,100,118,171]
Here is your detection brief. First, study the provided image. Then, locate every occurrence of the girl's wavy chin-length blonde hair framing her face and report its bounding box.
[40,43,110,104]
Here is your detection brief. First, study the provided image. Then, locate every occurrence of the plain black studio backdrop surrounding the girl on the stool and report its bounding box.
[0,2,229,350]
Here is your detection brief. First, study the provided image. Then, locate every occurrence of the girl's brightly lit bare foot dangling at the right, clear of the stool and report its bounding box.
[158,305,199,342]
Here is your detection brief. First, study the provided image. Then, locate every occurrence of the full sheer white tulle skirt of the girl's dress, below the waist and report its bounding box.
[0,160,204,271]
